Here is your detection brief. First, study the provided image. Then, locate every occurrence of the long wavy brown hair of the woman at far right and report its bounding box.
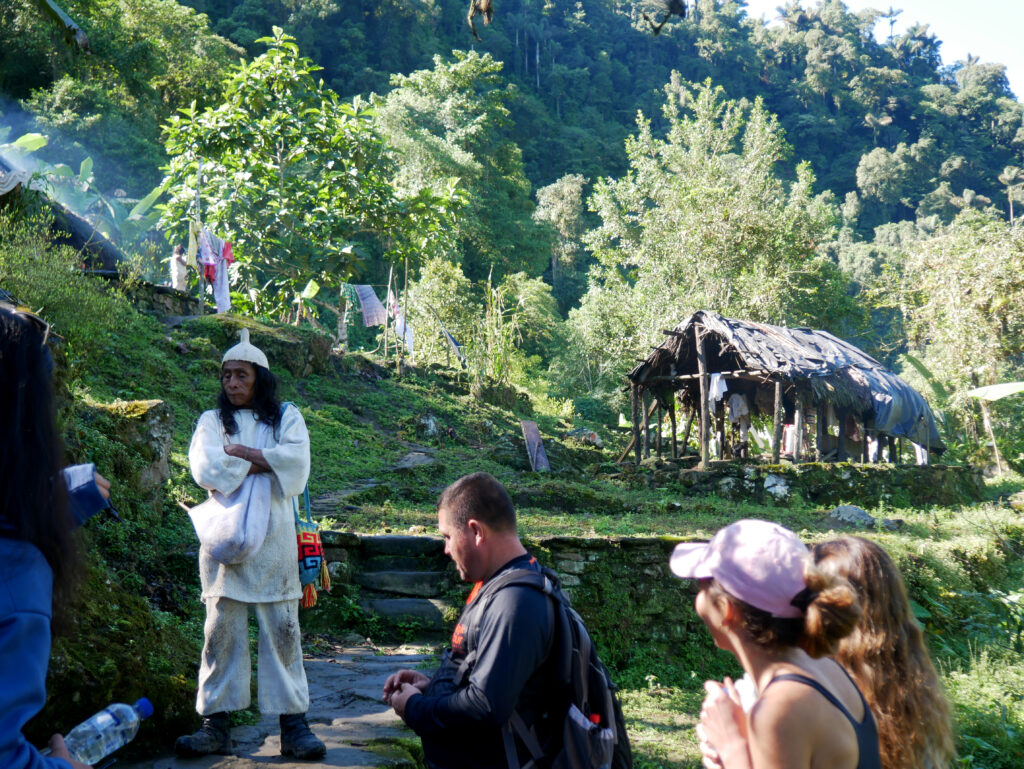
[811,537,955,769]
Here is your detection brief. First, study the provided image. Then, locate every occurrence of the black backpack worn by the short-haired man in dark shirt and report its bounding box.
[460,567,633,769]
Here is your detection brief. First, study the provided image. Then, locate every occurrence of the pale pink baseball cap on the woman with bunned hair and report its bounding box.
[669,519,810,617]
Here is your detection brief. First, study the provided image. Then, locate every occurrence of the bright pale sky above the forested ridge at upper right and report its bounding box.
[746,0,1024,99]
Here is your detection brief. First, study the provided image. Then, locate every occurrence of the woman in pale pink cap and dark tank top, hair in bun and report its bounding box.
[671,520,882,769]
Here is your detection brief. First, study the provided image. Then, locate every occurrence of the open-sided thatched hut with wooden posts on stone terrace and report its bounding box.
[628,310,944,462]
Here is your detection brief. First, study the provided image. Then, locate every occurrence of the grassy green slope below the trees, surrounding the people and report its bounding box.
[0,219,1024,769]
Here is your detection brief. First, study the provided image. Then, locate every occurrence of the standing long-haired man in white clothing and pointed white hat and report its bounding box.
[174,330,327,760]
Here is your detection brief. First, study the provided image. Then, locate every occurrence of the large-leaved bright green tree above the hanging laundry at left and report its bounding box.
[164,28,396,325]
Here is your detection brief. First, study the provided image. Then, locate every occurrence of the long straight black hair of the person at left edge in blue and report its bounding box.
[0,308,81,620]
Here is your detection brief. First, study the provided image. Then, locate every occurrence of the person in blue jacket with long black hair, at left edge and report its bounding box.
[0,307,85,769]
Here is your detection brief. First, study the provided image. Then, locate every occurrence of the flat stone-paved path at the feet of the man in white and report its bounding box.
[114,646,431,769]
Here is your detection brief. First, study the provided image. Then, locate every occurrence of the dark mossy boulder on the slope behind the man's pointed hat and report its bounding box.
[185,314,332,377]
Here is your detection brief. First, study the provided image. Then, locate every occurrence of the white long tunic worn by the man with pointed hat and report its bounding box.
[188,405,309,603]
